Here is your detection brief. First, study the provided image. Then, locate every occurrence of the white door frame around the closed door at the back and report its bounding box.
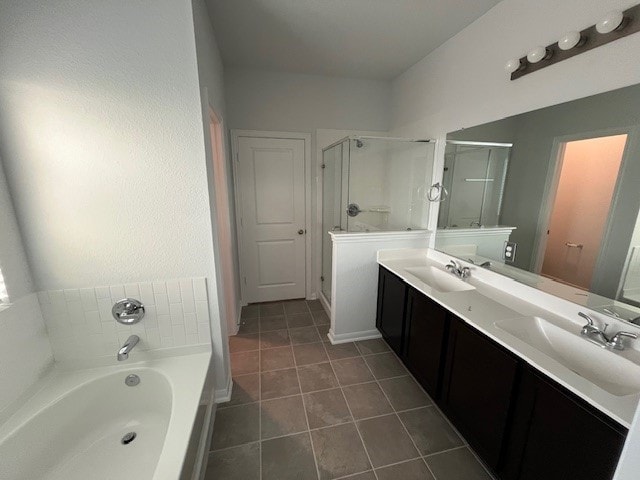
[231,129,315,305]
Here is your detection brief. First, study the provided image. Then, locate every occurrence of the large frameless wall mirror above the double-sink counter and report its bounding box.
[436,85,640,324]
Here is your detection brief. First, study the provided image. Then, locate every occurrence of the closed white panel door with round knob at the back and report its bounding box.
[237,136,306,303]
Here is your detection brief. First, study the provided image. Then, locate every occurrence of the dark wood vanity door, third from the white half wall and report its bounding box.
[440,315,524,470]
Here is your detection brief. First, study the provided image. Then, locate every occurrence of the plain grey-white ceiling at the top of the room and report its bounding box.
[207,0,500,79]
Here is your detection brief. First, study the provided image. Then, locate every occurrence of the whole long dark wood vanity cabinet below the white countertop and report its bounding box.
[376,267,627,480]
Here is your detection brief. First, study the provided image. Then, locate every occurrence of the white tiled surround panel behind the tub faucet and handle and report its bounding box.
[38,278,211,362]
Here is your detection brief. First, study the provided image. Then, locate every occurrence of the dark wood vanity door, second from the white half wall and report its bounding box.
[404,287,448,398]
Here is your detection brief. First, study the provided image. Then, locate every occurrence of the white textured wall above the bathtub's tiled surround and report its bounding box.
[0,0,228,394]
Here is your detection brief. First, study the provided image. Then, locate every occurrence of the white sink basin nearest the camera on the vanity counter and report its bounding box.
[495,317,640,397]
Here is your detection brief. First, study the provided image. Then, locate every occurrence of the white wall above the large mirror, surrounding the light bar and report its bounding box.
[391,0,640,480]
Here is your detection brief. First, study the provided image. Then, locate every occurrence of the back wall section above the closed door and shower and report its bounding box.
[225,68,391,132]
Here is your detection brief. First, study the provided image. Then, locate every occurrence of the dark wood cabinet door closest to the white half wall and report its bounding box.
[376,267,407,355]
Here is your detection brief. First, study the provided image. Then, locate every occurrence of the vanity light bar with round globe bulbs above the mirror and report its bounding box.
[504,4,640,80]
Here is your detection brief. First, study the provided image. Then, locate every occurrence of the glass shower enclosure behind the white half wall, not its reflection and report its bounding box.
[321,136,434,303]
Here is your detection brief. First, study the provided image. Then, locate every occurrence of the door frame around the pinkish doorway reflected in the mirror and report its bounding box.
[532,127,633,277]
